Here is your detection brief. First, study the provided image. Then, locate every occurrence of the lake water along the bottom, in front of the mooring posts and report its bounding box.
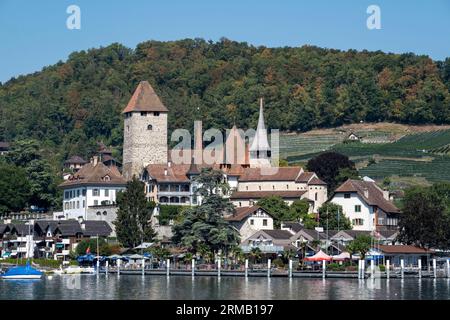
[0,274,450,300]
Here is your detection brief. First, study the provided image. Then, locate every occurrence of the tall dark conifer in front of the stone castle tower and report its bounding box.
[113,177,155,248]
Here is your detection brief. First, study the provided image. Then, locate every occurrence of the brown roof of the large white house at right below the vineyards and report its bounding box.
[335,179,400,213]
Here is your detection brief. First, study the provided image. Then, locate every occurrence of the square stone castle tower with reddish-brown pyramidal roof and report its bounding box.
[122,81,169,180]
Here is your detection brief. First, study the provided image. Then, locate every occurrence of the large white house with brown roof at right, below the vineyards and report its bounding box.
[330,179,400,231]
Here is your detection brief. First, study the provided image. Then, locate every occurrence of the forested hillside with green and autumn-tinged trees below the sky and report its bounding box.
[0,39,450,166]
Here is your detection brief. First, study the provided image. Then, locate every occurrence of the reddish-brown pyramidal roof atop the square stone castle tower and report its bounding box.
[122,81,169,113]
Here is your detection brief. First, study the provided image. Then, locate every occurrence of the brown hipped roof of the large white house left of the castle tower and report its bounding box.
[59,161,126,188]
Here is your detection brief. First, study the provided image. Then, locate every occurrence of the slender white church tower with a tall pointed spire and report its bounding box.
[250,98,272,168]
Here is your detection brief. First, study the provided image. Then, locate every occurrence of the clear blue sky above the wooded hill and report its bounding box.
[0,0,450,81]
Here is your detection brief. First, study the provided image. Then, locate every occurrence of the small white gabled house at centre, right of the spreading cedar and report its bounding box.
[225,206,273,241]
